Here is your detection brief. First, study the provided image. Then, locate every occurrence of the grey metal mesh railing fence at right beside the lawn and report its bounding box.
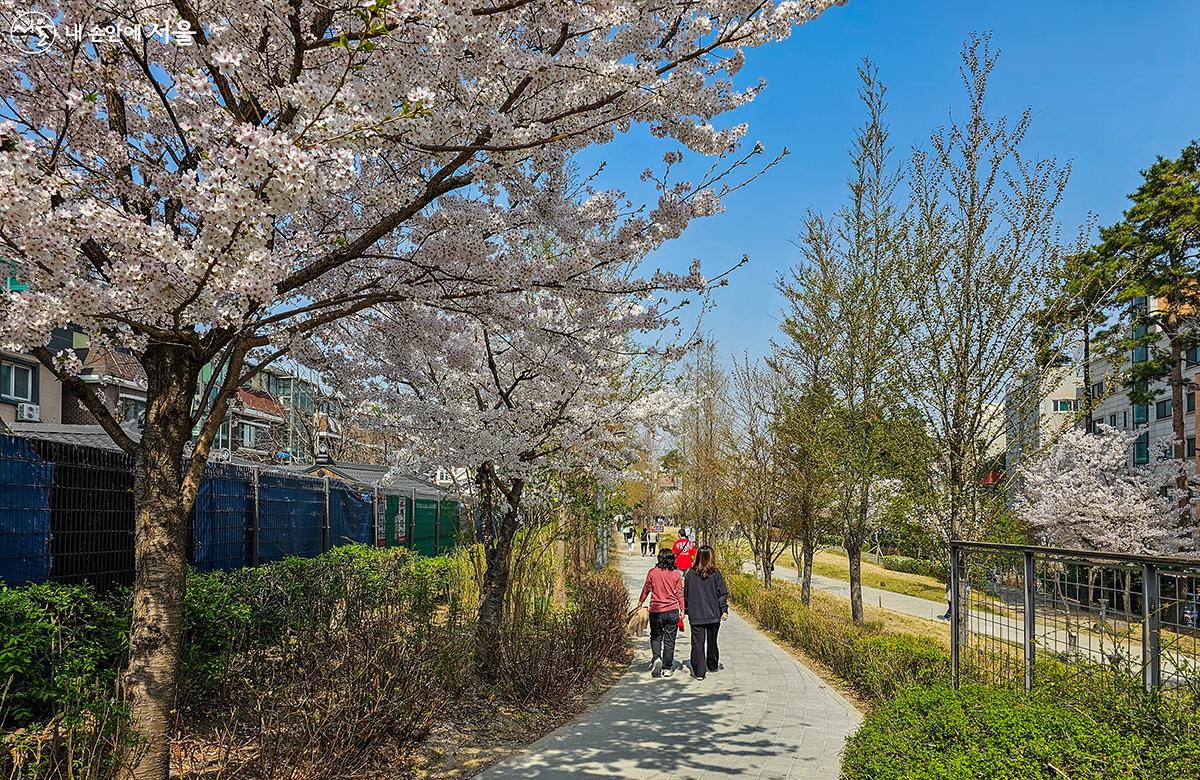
[950,541,1200,691]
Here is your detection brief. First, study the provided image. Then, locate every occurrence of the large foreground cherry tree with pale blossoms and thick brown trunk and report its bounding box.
[0,0,830,778]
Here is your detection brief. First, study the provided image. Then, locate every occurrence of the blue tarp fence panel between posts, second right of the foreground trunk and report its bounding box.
[258,472,325,563]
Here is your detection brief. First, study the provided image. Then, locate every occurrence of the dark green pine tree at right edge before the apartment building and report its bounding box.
[1096,142,1200,518]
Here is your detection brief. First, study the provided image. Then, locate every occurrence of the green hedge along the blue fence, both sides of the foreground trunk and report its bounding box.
[0,545,473,727]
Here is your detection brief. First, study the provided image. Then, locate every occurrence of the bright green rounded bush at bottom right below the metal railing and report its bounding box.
[842,684,1152,780]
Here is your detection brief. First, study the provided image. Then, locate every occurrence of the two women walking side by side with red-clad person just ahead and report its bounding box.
[637,528,730,679]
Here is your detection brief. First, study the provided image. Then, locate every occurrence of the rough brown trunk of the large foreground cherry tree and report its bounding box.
[124,344,198,780]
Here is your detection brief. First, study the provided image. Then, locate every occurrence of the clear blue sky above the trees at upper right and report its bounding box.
[584,0,1200,360]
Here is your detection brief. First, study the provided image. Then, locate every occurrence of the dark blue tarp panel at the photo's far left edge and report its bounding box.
[0,436,54,586]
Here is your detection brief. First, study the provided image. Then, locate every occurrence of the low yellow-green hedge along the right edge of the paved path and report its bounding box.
[728,574,950,702]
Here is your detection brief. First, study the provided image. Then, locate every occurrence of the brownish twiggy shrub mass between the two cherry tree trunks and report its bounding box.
[206,550,473,779]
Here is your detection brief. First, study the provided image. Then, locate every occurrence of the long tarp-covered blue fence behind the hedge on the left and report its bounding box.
[0,434,457,588]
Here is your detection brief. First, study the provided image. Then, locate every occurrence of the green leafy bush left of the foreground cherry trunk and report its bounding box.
[0,583,128,727]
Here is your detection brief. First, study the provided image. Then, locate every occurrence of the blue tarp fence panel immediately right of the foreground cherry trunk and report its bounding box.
[192,463,254,571]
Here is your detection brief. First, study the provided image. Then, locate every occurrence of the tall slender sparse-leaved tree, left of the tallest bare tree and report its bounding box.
[781,61,911,623]
